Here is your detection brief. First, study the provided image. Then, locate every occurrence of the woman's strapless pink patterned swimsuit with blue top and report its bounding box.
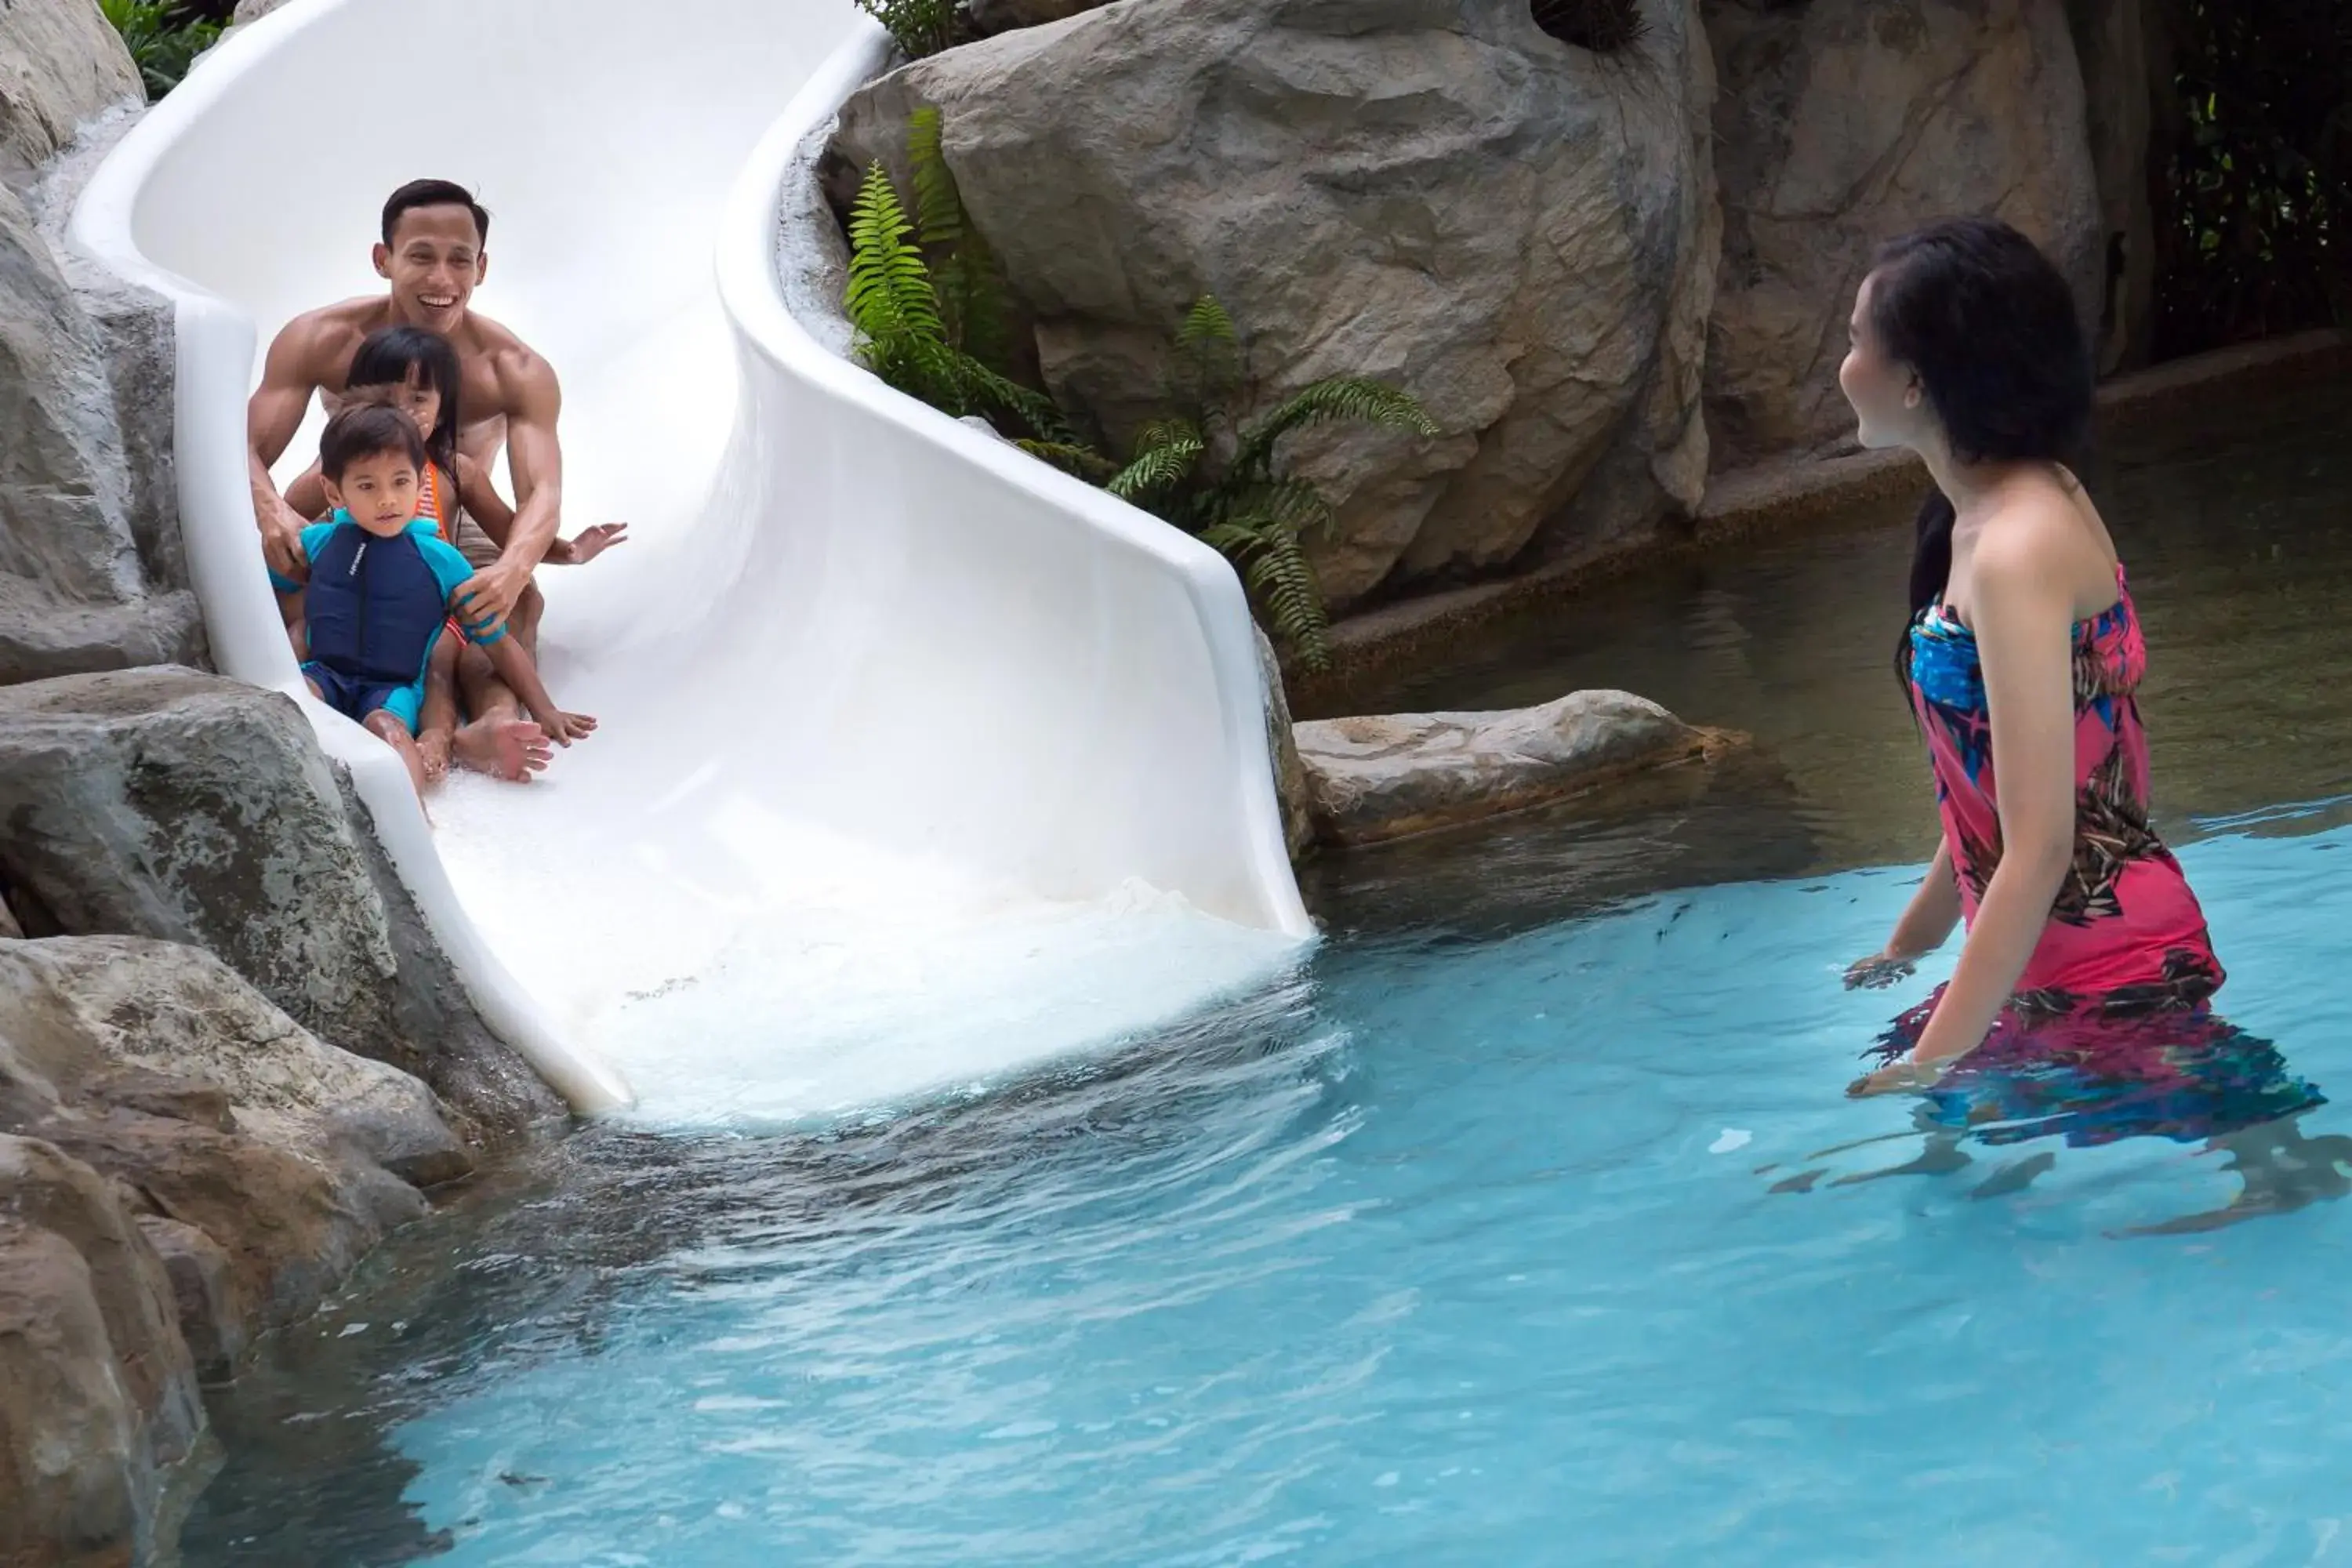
[1910,567,2223,1020]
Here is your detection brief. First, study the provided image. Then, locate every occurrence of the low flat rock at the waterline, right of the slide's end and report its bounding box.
[1298,691,1722,844]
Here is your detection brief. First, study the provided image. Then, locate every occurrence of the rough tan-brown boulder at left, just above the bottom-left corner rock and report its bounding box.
[0,938,473,1370]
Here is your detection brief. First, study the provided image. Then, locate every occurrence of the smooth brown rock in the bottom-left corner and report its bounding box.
[0,1133,205,1568]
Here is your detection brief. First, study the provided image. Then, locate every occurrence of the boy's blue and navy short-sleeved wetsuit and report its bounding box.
[270,513,506,736]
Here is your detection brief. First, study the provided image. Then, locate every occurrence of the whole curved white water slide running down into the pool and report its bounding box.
[71,0,1310,1123]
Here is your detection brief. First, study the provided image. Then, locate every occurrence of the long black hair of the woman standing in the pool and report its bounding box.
[1870,219,2093,689]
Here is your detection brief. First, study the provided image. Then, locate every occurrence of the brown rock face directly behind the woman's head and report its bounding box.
[1705,0,2105,463]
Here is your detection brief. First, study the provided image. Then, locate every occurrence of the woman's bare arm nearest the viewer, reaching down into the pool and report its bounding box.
[1870,520,2074,1086]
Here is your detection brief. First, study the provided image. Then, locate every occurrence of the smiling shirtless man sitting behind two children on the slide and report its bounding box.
[245,179,562,781]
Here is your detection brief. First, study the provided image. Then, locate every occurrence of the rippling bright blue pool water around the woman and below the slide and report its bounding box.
[191,829,2352,1568]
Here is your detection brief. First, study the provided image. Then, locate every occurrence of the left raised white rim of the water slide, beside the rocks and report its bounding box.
[66,7,633,1116]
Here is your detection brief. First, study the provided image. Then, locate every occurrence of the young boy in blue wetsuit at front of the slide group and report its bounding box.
[270,402,595,799]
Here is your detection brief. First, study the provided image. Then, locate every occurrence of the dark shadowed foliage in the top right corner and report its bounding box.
[2157,0,2352,358]
